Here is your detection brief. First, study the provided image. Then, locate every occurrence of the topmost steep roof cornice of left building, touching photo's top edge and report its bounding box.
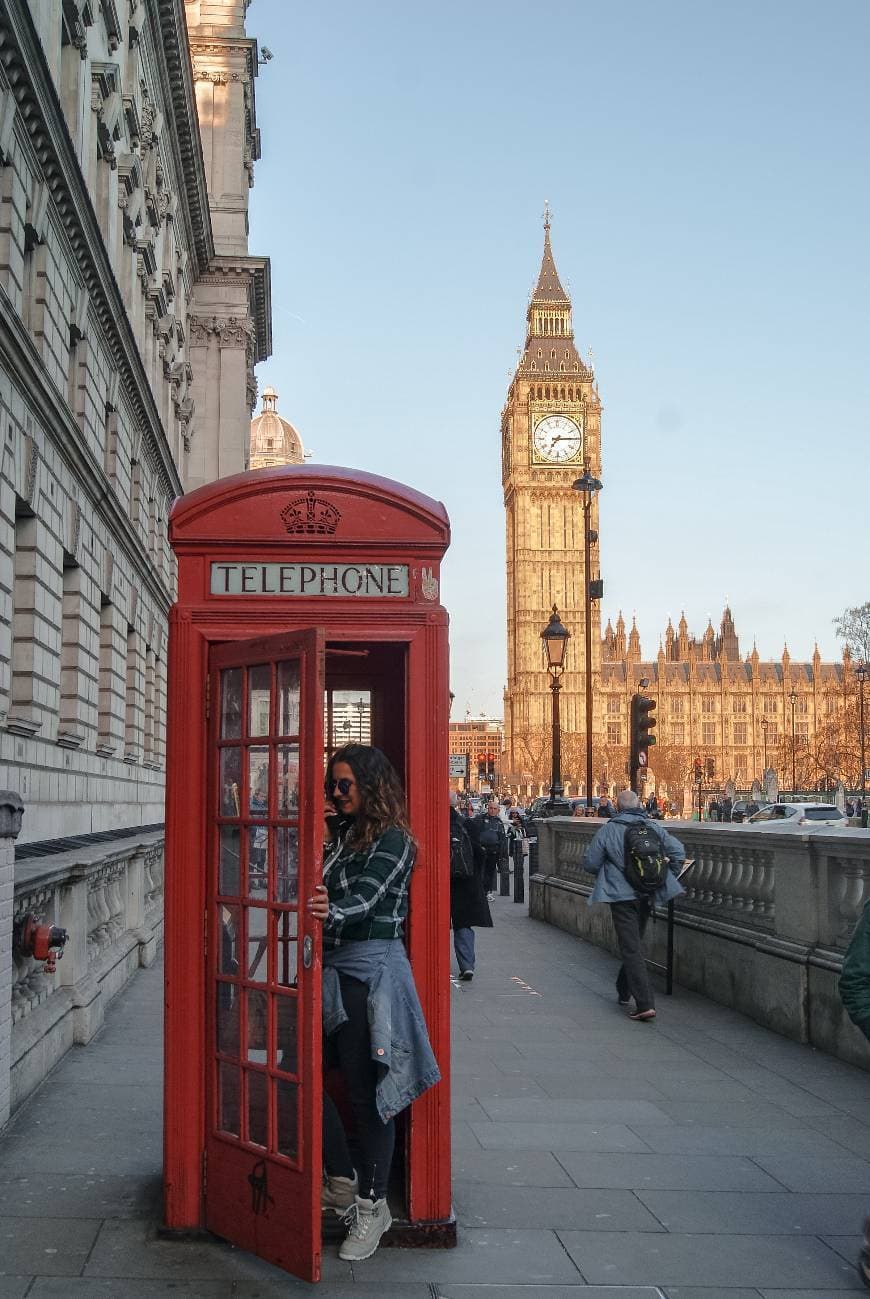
[153,0,214,270]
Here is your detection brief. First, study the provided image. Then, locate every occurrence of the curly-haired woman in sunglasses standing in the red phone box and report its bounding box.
[308,744,440,1263]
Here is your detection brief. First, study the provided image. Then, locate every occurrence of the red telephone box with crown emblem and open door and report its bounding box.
[164,465,454,1281]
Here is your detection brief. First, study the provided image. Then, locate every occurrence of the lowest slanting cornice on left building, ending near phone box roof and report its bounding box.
[0,286,180,614]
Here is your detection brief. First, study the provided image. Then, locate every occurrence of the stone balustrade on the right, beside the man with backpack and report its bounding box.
[530,817,870,1068]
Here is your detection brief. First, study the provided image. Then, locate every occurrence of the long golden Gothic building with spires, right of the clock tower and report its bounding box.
[595,607,861,794]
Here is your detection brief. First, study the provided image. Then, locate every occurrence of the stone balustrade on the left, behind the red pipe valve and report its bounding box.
[0,831,164,1121]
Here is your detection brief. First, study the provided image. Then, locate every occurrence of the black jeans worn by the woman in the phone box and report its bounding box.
[323,974,396,1200]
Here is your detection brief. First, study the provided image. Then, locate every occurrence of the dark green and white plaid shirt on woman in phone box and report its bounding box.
[323,826,417,948]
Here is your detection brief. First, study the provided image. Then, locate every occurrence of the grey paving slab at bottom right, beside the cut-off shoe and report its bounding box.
[558,1231,854,1289]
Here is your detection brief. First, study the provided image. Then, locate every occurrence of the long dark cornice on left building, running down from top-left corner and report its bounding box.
[0,0,182,498]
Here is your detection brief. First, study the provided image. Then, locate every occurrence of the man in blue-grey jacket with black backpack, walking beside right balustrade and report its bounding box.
[583,790,686,1021]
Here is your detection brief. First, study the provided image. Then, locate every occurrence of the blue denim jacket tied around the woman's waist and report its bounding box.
[322,938,441,1122]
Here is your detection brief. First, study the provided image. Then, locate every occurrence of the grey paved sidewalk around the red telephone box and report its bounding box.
[0,898,870,1299]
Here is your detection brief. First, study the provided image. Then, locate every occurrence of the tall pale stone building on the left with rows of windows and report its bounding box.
[0,0,270,842]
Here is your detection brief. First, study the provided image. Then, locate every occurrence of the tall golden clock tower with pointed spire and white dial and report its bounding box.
[501,209,601,785]
